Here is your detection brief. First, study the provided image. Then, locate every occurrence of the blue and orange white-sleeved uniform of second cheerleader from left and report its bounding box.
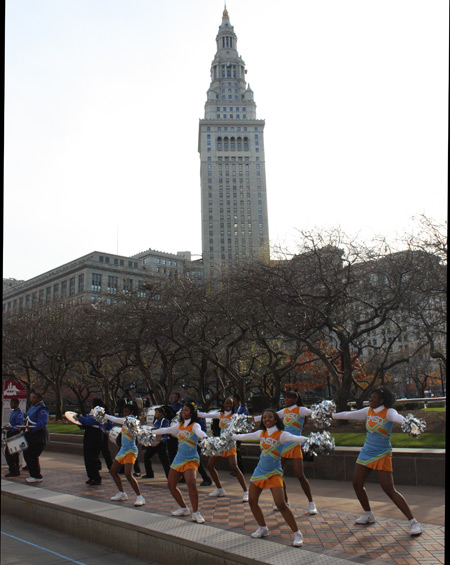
[152,419,206,473]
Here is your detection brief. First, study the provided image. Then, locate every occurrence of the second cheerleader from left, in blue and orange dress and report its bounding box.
[152,403,206,524]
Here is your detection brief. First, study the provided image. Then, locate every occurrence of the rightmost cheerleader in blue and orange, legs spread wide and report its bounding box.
[332,388,422,536]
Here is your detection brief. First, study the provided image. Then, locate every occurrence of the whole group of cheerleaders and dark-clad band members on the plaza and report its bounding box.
[5,388,422,547]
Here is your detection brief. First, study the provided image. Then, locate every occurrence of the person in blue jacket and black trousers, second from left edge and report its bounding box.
[23,392,49,483]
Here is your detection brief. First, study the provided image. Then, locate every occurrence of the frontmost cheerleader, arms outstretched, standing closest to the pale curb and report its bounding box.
[232,409,307,547]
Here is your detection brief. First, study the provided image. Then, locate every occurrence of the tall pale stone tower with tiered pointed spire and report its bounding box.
[198,8,269,276]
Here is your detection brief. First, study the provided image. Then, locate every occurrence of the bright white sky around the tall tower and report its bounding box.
[3,0,449,280]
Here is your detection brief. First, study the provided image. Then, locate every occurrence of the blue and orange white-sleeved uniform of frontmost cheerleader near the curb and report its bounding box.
[232,426,307,489]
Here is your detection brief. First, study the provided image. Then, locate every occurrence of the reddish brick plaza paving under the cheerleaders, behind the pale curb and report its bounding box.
[2,452,445,565]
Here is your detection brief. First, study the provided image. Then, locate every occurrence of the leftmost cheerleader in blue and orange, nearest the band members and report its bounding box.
[106,404,145,506]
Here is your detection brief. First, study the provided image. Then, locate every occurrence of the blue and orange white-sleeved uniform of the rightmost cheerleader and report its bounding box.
[332,405,405,472]
